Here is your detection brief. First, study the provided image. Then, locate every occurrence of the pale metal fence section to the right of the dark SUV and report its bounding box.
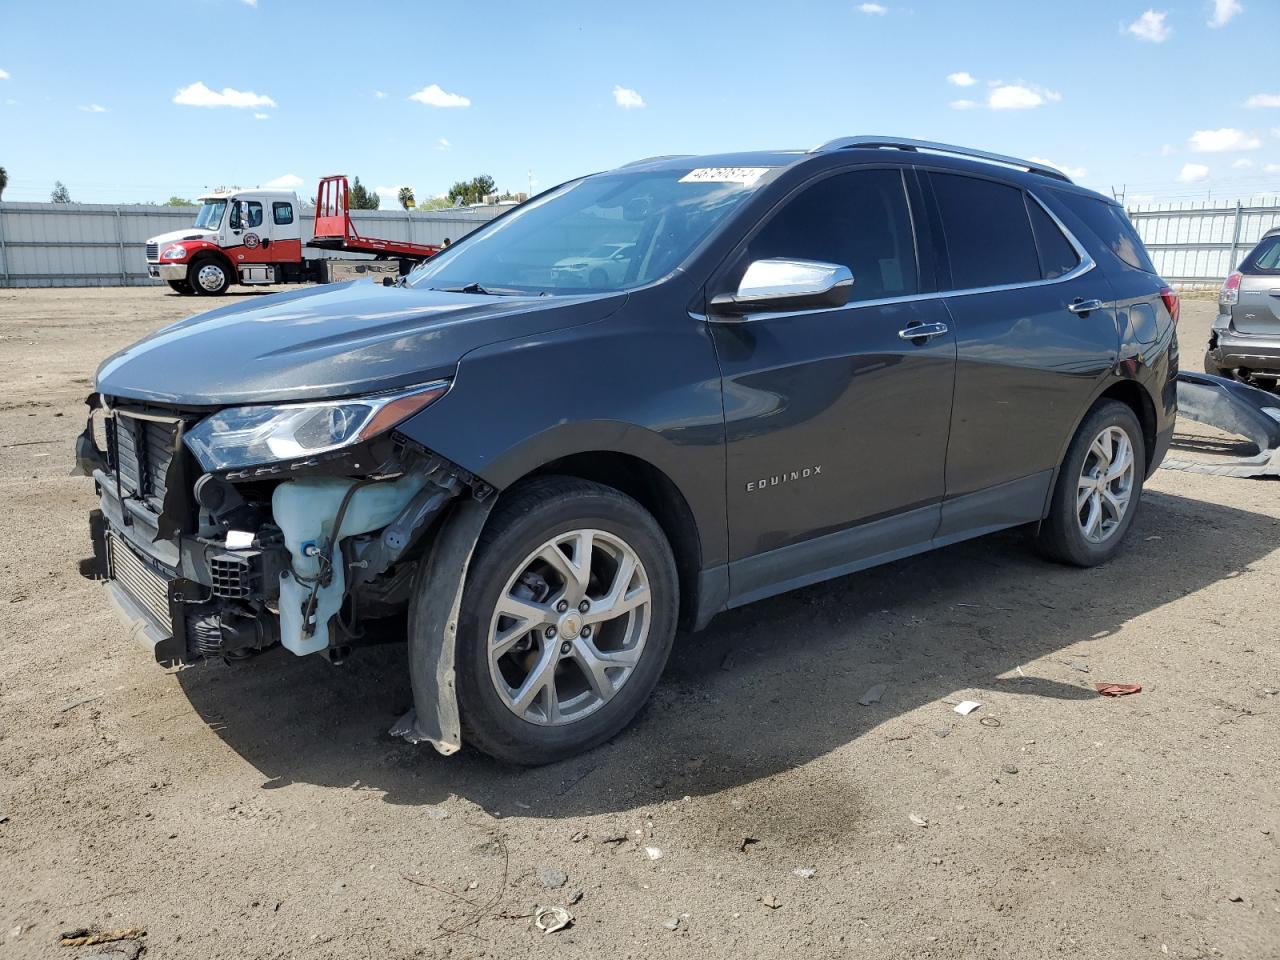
[1129,197,1280,287]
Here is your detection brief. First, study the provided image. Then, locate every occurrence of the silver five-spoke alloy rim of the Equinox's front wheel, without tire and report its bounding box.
[488,530,652,726]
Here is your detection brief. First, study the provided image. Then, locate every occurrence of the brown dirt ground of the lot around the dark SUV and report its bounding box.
[0,288,1280,960]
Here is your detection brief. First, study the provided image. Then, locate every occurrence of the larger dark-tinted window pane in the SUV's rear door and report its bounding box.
[929,173,1041,291]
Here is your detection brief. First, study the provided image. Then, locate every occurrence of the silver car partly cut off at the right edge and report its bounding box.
[1204,229,1280,390]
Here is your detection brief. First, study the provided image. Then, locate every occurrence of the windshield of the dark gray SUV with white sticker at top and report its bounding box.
[408,166,777,294]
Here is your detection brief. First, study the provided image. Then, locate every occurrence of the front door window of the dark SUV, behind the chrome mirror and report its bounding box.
[735,169,920,301]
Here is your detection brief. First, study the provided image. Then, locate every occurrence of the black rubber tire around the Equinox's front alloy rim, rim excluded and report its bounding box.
[456,476,680,765]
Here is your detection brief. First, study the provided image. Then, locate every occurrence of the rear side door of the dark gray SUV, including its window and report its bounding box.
[927,170,1119,539]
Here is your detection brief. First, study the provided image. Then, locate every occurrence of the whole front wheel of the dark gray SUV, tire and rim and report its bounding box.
[457,476,680,765]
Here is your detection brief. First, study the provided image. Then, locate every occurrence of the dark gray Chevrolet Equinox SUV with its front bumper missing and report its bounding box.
[77,137,1179,763]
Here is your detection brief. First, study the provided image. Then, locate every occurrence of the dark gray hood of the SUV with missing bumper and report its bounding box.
[97,280,626,406]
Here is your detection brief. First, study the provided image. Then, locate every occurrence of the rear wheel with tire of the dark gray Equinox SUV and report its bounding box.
[1037,401,1147,567]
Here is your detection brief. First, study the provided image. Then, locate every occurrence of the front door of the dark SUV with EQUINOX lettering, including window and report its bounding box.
[709,168,955,602]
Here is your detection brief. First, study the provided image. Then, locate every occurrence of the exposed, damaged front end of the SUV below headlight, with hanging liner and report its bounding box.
[76,396,497,755]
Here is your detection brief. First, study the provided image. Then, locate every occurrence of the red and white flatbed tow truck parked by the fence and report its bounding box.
[146,174,440,297]
